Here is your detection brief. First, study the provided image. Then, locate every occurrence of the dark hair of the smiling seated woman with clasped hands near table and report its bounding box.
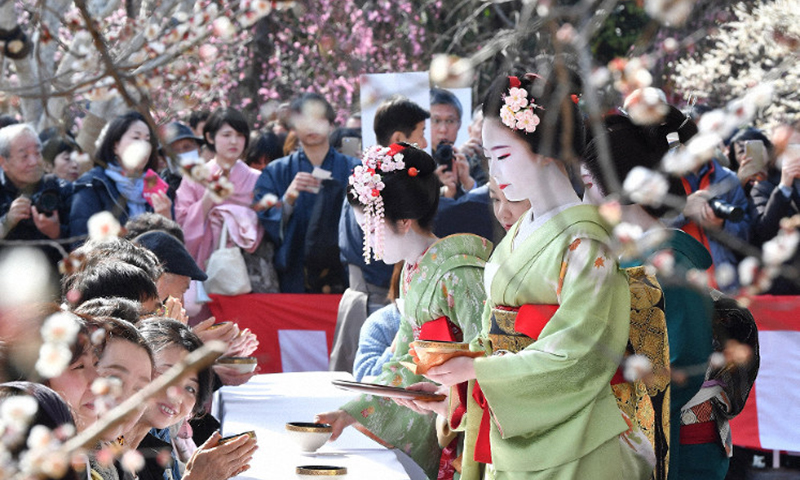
[138,317,213,416]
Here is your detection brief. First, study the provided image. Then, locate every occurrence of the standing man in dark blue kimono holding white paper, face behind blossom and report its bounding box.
[254,92,356,293]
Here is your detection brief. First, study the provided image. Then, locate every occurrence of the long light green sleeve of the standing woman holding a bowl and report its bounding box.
[475,238,630,470]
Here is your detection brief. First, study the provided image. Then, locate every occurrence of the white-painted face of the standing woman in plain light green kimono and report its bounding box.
[483,119,548,202]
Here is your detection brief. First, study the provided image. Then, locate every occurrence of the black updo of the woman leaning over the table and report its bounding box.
[347,143,441,231]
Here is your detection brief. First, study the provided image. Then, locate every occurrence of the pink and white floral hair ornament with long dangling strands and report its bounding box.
[350,143,410,263]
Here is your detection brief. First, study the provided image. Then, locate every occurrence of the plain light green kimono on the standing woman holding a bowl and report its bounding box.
[462,205,631,479]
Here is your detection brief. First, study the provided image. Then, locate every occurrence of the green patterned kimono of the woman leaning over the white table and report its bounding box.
[342,234,492,478]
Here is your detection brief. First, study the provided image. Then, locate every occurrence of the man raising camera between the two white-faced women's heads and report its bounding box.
[431,88,488,198]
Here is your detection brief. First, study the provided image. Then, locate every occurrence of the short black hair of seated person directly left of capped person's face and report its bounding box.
[71,259,158,306]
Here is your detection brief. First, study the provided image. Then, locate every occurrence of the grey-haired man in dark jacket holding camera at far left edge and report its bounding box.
[0,124,72,265]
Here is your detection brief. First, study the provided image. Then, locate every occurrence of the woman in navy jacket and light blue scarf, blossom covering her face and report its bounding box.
[69,111,172,246]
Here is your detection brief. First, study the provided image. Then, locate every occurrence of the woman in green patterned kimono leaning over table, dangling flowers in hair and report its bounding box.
[316,144,492,478]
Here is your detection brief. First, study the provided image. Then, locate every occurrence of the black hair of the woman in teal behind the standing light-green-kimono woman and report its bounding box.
[583,106,697,217]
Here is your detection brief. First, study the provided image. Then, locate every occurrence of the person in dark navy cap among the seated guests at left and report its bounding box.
[133,231,208,300]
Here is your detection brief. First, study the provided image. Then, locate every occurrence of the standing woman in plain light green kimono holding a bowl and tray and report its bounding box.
[418,74,640,480]
